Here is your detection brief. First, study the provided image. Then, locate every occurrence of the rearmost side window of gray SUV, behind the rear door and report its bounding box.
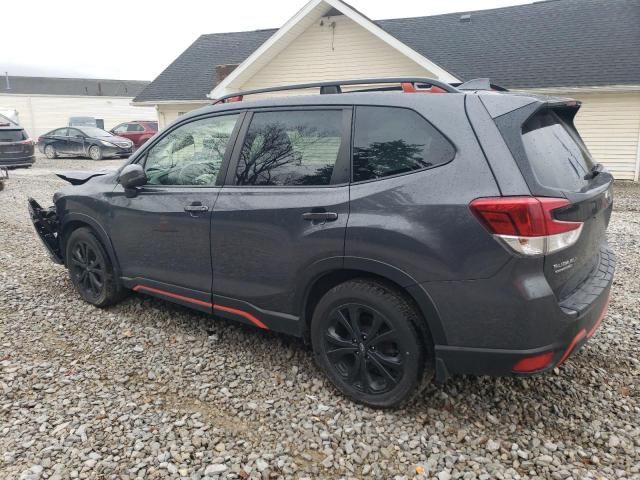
[353,107,455,182]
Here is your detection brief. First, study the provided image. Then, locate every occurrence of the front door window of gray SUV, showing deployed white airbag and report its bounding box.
[144,115,239,185]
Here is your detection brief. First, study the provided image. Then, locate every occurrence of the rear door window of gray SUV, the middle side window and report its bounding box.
[236,110,342,185]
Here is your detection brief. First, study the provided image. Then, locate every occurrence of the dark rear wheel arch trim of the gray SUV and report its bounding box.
[298,257,446,345]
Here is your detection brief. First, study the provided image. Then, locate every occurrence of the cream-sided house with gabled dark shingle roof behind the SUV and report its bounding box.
[134,0,640,181]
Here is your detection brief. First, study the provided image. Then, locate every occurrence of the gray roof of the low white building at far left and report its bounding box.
[0,75,149,97]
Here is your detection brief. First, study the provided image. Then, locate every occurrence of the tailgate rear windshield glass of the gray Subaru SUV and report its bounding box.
[522,110,594,190]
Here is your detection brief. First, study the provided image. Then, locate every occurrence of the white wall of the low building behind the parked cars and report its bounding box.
[0,94,157,139]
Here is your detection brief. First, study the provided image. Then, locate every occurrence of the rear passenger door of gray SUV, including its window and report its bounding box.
[211,107,351,334]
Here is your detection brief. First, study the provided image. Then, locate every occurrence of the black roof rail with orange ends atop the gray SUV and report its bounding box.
[214,77,461,105]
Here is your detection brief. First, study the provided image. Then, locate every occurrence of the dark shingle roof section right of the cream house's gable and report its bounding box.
[377,0,640,88]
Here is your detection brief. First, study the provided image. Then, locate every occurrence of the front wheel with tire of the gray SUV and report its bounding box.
[65,227,126,308]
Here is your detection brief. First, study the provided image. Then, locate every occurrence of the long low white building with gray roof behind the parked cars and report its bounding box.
[0,76,157,138]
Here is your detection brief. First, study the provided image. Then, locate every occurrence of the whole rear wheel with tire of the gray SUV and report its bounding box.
[311,279,427,408]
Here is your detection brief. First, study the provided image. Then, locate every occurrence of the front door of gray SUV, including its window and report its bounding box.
[110,114,241,304]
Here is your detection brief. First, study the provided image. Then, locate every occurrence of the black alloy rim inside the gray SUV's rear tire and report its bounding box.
[324,303,404,394]
